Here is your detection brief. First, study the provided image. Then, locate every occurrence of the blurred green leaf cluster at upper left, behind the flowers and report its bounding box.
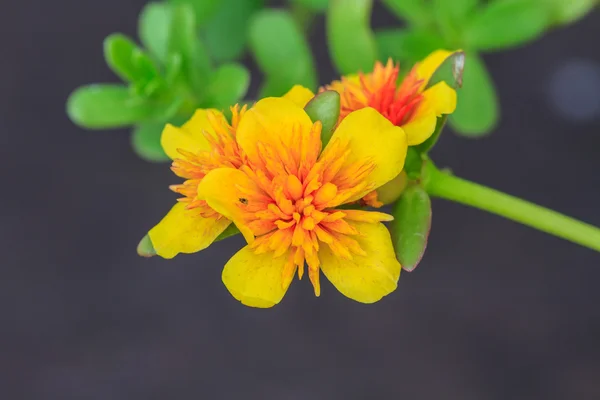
[67,0,328,161]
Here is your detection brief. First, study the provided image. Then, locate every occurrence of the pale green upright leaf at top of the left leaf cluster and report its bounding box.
[138,3,172,63]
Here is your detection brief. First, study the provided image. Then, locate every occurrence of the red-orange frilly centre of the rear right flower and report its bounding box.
[341,59,423,126]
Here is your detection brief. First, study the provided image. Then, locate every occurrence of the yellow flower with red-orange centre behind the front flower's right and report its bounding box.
[326,50,456,146]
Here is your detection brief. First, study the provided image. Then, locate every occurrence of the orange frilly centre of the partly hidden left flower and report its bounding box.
[170,105,246,218]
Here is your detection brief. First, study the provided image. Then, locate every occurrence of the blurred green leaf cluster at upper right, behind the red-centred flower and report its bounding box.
[327,0,598,136]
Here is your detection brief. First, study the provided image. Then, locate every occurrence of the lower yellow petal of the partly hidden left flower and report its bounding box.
[148,203,231,258]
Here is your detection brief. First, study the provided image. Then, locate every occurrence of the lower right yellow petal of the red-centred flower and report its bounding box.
[402,82,456,146]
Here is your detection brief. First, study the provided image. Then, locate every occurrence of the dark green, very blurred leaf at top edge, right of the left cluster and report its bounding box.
[202,0,264,63]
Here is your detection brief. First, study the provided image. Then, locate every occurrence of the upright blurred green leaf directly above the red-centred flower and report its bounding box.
[327,0,377,75]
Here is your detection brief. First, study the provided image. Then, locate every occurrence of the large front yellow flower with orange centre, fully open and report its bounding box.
[198,96,407,307]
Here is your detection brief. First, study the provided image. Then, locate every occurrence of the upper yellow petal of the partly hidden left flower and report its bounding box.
[160,109,226,160]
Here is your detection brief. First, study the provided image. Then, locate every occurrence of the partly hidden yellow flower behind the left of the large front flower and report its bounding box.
[142,106,246,258]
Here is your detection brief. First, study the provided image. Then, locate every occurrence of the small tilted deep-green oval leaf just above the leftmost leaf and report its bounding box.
[104,33,158,82]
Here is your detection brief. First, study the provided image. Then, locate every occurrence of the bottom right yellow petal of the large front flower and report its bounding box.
[319,222,402,303]
